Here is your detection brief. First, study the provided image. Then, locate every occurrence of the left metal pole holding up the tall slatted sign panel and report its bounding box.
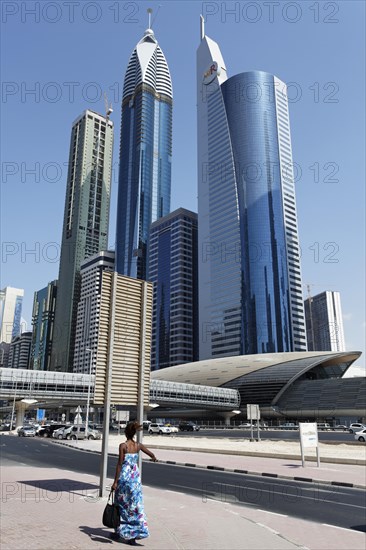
[99,272,117,497]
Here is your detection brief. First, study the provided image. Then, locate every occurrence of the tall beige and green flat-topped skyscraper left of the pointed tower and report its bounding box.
[51,110,113,371]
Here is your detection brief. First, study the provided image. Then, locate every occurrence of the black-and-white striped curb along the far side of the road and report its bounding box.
[52,440,366,489]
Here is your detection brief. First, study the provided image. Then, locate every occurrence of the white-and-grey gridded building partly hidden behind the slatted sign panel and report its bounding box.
[73,251,114,374]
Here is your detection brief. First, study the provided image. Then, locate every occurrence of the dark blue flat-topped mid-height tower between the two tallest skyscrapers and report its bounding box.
[149,208,198,370]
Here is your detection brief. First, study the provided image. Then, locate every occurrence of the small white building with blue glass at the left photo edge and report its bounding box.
[0,286,24,344]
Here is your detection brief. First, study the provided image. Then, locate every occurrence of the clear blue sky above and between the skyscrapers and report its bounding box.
[1,0,365,365]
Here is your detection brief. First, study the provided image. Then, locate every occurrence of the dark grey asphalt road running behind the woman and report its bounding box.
[0,436,366,532]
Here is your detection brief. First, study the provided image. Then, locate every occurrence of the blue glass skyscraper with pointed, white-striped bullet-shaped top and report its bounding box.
[116,20,173,279]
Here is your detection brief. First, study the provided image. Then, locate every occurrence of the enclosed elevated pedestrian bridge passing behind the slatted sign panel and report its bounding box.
[0,368,240,411]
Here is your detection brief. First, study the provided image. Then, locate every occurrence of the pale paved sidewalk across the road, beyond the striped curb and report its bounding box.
[55,436,366,488]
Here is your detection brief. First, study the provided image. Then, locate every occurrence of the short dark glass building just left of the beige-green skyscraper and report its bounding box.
[30,281,57,370]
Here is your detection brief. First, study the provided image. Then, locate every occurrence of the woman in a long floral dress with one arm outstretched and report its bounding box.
[112,422,157,544]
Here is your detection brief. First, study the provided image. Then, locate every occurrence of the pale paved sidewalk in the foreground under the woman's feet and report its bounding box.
[1,462,365,550]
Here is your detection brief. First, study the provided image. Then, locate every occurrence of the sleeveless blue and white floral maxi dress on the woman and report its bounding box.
[115,453,149,540]
